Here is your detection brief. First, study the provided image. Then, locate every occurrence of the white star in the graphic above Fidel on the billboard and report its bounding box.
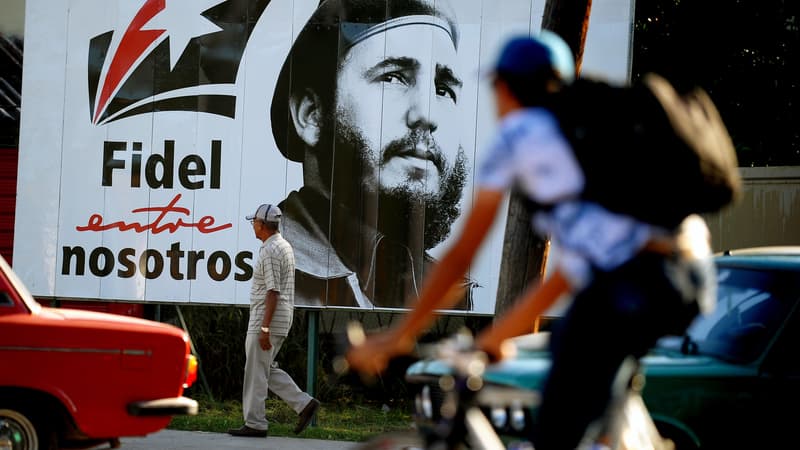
[142,0,227,70]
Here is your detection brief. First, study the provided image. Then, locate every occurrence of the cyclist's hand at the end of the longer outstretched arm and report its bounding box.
[347,330,413,375]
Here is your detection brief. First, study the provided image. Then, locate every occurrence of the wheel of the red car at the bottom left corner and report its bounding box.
[0,406,58,450]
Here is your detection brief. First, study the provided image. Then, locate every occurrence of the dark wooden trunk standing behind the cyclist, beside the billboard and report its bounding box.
[494,0,592,316]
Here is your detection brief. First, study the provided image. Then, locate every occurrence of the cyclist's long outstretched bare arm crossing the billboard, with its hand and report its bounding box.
[347,189,504,373]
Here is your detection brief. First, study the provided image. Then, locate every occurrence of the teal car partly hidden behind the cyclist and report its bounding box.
[406,247,800,450]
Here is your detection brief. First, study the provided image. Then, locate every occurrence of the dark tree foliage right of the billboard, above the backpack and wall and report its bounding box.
[632,0,800,166]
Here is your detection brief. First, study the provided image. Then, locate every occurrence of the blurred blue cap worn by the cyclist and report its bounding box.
[494,30,575,82]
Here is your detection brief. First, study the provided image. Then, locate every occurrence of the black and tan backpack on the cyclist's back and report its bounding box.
[547,74,741,229]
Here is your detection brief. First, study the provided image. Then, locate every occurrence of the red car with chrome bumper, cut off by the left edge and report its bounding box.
[0,256,197,450]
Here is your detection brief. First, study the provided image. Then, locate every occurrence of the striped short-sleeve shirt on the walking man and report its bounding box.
[247,233,294,336]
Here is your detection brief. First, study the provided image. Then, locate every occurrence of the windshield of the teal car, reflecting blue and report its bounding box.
[687,265,800,363]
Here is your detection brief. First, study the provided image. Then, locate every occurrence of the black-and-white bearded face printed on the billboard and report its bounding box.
[334,24,465,200]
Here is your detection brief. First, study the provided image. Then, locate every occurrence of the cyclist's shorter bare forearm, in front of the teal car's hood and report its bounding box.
[476,270,570,359]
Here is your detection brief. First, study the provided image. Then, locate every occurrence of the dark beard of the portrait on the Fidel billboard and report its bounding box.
[332,114,467,249]
